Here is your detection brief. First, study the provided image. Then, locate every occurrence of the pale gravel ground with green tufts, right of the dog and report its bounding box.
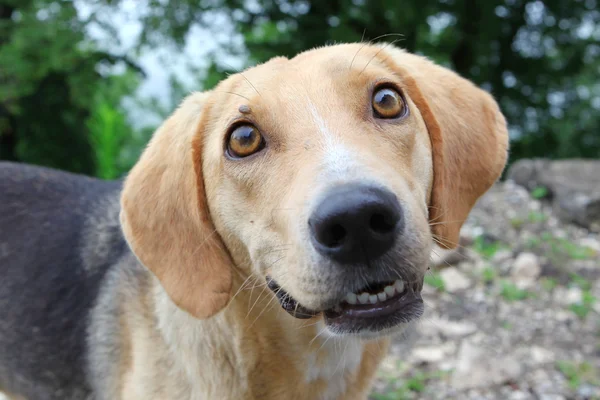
[371,181,600,400]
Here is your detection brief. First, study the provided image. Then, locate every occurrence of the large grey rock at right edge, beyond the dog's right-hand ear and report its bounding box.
[508,159,600,232]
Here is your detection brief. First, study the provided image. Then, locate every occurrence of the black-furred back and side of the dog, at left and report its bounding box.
[0,162,136,399]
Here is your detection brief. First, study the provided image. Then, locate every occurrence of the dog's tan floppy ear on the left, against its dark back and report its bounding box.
[121,94,232,318]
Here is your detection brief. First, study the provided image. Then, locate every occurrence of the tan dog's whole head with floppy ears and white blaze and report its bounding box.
[121,44,507,337]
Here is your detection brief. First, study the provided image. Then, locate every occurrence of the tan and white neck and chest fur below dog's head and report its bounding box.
[155,276,388,400]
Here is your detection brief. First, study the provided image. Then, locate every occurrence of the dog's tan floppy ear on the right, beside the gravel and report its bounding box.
[386,45,508,248]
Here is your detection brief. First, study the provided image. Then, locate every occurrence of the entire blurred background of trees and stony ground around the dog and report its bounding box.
[0,0,600,400]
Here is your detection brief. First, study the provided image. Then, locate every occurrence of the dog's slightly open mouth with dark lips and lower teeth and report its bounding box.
[267,277,424,334]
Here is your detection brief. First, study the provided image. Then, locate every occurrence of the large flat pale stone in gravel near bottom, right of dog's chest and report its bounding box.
[451,340,523,390]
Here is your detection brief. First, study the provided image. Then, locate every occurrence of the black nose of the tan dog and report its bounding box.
[308,184,403,264]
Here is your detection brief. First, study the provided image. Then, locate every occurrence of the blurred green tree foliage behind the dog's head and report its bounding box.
[0,0,600,178]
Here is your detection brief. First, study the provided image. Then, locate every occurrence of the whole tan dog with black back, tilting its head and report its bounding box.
[0,43,508,400]
